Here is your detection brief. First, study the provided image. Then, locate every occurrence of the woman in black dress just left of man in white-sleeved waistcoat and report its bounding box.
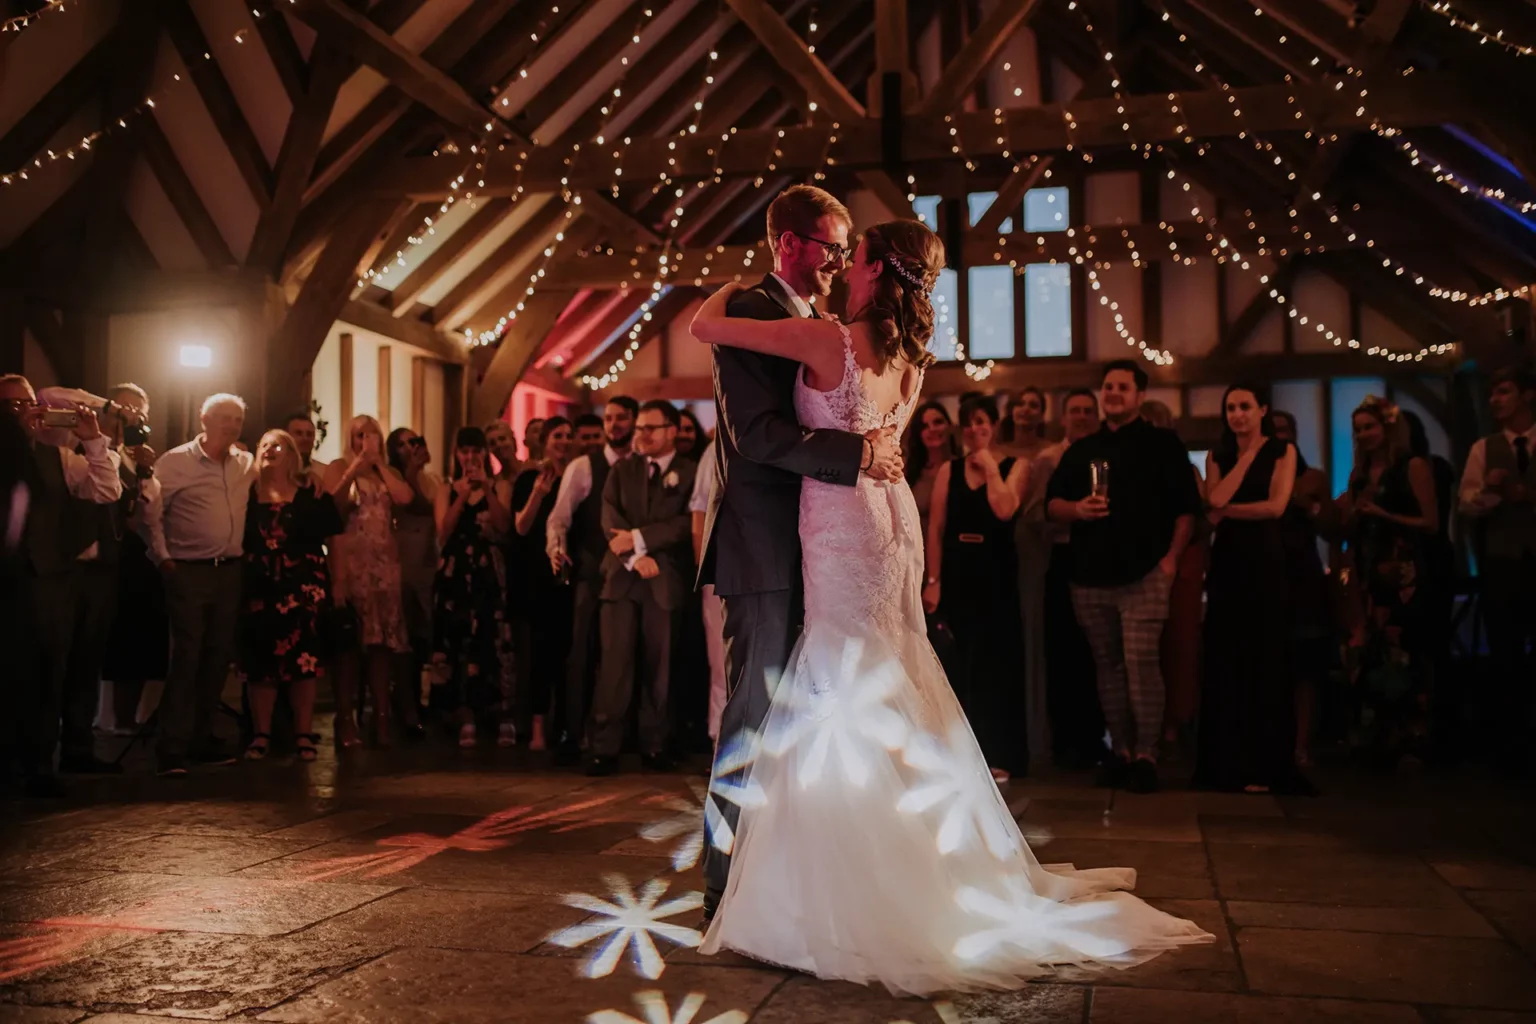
[507,416,576,751]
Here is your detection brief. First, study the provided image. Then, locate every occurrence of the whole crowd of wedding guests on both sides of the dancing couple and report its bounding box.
[0,361,1536,795]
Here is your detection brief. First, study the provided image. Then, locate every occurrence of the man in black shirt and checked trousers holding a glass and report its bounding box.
[1046,359,1201,792]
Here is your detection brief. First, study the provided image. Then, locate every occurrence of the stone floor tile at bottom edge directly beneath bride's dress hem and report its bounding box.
[753,976,1087,1024]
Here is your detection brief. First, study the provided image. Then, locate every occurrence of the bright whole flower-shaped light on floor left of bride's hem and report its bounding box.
[548,875,703,979]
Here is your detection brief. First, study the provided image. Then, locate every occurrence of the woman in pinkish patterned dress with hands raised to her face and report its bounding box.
[326,416,416,746]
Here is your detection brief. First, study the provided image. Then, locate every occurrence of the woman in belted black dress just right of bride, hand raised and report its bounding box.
[923,398,1029,781]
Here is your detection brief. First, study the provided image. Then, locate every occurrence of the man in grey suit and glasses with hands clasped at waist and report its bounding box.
[587,401,696,775]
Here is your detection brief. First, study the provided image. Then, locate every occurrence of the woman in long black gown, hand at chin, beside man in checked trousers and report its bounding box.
[1192,384,1312,794]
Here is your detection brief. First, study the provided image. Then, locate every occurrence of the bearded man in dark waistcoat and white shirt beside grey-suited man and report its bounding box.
[544,395,641,765]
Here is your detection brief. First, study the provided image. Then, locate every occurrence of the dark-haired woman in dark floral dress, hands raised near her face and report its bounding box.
[433,427,515,746]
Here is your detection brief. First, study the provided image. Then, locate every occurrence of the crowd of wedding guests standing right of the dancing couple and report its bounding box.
[906,361,1536,794]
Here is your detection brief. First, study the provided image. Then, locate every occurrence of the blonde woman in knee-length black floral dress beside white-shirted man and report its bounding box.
[240,430,343,761]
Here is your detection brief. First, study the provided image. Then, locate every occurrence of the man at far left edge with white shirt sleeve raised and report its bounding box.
[0,375,123,797]
